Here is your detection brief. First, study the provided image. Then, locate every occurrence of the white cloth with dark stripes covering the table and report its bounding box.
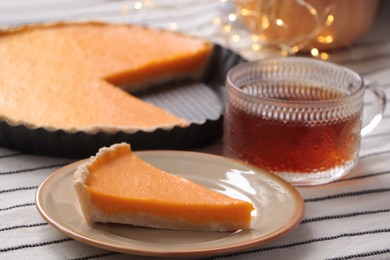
[0,0,390,259]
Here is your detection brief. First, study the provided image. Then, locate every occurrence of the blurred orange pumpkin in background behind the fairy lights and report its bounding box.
[234,0,379,51]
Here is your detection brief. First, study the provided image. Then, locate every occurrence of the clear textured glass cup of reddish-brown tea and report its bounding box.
[224,57,386,186]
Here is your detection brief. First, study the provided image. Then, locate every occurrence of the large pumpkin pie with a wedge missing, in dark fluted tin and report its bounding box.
[0,22,213,133]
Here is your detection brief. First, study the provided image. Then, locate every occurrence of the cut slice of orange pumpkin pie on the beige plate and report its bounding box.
[73,143,253,231]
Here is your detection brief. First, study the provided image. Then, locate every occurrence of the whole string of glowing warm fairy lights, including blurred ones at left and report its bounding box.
[120,0,335,60]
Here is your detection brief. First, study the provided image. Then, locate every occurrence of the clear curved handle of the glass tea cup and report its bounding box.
[360,82,386,136]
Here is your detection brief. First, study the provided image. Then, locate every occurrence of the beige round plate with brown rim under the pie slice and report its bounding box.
[36,151,304,257]
